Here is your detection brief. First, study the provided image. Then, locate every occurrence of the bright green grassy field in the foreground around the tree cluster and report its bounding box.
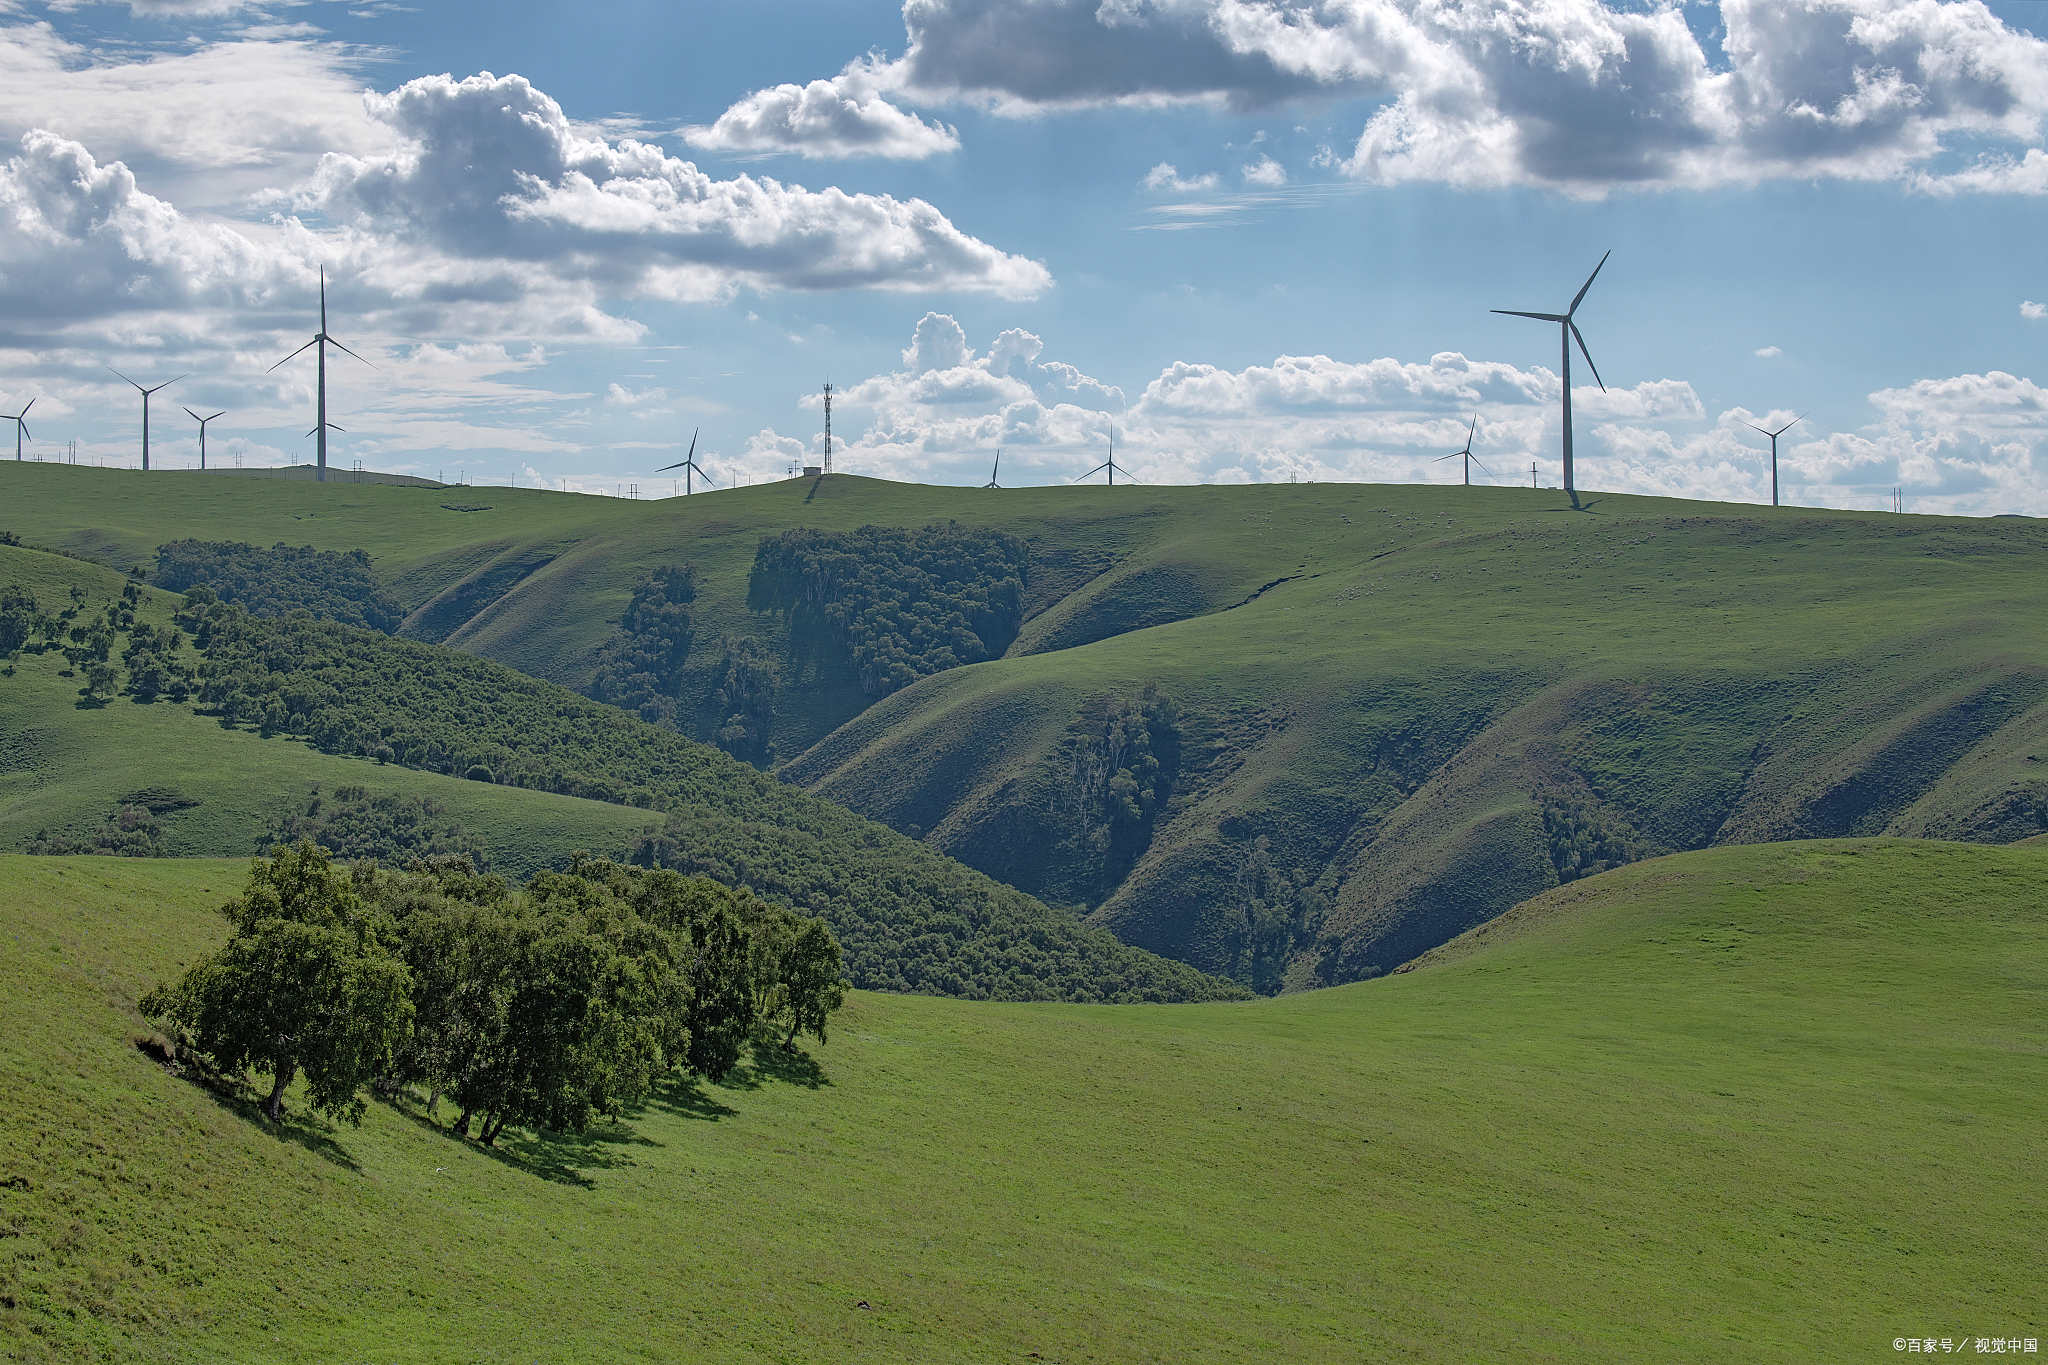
[0,841,2048,1363]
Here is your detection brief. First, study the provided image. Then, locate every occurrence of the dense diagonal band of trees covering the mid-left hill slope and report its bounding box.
[184,604,1239,1001]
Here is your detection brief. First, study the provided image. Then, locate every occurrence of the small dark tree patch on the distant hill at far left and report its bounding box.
[152,540,406,634]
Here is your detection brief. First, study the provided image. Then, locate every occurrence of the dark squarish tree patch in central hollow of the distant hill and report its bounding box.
[748,524,1028,698]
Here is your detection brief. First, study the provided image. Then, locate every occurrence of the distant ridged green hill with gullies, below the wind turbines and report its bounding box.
[0,465,2048,990]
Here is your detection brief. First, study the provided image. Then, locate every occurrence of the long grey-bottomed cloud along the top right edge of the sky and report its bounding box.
[735,0,2048,196]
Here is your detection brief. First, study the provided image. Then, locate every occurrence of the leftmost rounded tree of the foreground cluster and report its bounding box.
[141,843,412,1124]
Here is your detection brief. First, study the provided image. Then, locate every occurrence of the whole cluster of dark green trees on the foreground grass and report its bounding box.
[141,841,844,1142]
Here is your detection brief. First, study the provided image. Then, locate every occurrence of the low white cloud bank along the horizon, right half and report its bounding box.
[794,313,2048,512]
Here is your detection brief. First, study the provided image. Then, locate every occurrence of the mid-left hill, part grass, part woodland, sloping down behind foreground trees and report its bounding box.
[0,546,1243,1001]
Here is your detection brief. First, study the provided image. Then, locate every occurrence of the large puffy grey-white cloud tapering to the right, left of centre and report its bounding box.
[297,74,1053,301]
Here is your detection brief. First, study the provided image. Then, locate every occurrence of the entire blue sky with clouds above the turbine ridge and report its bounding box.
[0,0,2048,514]
